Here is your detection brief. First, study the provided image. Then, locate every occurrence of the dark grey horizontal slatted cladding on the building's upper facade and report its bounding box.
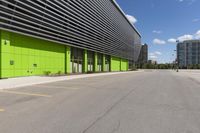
[0,0,141,60]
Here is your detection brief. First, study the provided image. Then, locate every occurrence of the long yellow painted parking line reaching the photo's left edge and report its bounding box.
[0,90,51,98]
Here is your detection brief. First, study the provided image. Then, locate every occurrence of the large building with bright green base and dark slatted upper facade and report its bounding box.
[0,0,141,78]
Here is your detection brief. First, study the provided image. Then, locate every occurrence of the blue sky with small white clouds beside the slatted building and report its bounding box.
[116,0,200,63]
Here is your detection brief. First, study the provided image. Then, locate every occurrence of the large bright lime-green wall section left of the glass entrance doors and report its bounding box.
[0,31,67,78]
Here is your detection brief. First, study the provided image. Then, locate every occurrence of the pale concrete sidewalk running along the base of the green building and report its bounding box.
[0,70,142,89]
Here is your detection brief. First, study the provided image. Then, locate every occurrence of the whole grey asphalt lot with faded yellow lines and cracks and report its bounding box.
[0,70,200,133]
